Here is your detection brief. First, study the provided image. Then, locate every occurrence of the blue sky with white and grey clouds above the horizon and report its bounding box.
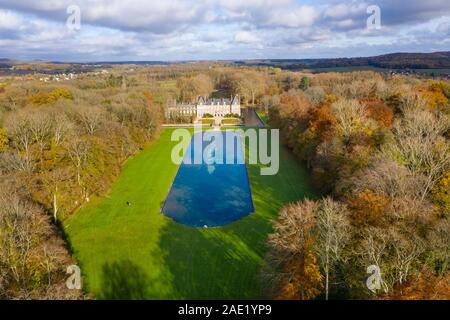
[0,0,450,62]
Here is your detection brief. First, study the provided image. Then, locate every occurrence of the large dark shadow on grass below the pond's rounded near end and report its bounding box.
[160,221,268,299]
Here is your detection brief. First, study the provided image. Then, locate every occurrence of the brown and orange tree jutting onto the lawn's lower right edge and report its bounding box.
[263,200,323,300]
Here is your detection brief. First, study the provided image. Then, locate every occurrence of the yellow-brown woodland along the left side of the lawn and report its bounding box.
[0,69,162,299]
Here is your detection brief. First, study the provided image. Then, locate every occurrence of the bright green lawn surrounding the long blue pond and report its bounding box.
[64,129,314,299]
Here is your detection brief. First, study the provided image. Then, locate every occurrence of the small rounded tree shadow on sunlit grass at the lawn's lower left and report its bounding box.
[99,260,148,300]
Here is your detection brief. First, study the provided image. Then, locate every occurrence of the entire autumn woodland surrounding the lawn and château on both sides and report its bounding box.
[0,63,450,299]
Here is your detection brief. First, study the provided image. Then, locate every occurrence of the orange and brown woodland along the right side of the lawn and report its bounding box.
[264,72,450,299]
